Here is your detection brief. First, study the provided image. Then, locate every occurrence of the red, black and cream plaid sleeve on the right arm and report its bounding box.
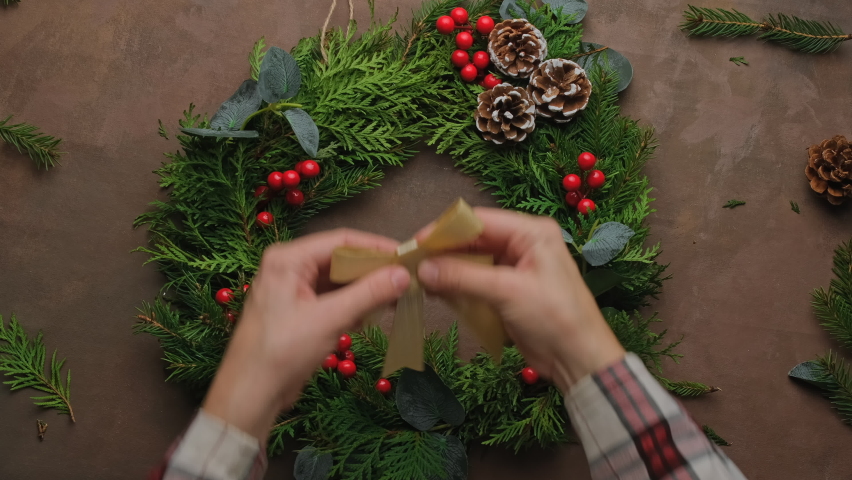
[565,353,745,480]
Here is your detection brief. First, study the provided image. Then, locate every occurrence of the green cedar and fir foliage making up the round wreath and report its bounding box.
[136,0,712,474]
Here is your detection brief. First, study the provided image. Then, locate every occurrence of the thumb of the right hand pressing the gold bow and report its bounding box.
[417,257,514,304]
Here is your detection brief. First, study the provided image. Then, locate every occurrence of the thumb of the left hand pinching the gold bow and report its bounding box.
[319,265,411,330]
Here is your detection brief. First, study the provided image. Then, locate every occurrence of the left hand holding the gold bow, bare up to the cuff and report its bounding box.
[203,229,410,442]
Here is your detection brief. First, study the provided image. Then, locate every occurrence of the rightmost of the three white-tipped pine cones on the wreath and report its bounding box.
[527,58,592,123]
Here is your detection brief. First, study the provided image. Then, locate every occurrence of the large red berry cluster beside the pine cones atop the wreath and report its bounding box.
[435,7,501,89]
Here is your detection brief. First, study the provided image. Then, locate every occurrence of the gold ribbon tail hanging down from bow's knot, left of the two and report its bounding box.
[382,277,425,377]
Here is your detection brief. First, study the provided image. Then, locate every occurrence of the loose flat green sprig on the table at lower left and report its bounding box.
[0,315,76,422]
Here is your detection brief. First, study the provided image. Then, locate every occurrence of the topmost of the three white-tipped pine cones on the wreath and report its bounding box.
[488,18,547,78]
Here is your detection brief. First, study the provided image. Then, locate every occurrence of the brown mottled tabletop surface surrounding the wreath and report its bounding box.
[0,0,852,479]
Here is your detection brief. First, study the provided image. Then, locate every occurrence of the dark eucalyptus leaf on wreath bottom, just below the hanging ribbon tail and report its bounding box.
[396,368,464,432]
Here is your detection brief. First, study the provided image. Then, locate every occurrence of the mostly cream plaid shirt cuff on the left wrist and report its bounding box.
[148,410,267,480]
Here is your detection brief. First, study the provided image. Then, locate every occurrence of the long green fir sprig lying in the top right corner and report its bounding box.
[680,5,852,53]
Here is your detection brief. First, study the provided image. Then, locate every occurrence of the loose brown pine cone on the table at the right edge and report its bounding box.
[805,135,852,205]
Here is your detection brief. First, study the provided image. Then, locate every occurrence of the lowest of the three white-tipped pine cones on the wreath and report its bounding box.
[474,83,535,145]
